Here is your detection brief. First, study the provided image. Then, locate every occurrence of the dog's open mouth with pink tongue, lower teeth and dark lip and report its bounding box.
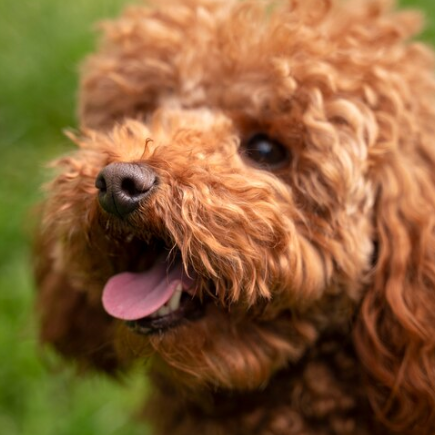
[102,244,205,334]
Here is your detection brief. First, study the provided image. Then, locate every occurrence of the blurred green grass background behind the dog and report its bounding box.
[0,0,435,435]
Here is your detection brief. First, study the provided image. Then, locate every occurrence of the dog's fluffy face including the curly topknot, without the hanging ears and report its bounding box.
[37,1,435,430]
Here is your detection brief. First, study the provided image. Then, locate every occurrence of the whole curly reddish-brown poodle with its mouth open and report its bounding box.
[36,0,435,435]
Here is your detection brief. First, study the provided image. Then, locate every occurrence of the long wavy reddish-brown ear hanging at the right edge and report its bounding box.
[354,147,435,435]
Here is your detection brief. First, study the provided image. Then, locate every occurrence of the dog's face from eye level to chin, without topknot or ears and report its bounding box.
[54,107,371,388]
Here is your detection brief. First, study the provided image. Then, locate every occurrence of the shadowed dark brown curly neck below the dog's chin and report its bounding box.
[147,335,385,435]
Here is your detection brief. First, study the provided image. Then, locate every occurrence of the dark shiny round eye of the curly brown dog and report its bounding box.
[241,133,290,169]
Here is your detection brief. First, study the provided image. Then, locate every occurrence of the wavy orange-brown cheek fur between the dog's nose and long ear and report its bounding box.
[149,171,325,305]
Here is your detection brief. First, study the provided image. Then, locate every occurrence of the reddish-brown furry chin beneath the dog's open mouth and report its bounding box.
[117,303,296,391]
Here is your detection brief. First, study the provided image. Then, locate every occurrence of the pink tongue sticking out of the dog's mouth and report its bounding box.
[103,261,183,320]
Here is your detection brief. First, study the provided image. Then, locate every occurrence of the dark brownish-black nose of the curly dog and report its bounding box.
[95,162,157,217]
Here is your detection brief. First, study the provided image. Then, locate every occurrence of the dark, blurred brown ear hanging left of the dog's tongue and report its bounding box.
[34,228,122,375]
